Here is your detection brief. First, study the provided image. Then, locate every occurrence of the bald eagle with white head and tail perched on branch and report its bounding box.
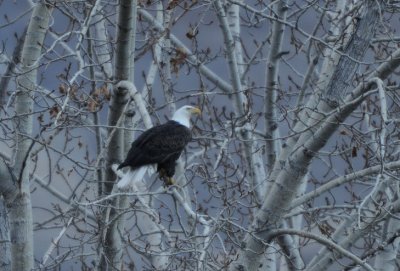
[117,105,201,189]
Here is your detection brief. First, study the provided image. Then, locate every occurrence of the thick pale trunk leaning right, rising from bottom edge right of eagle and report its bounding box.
[233,78,382,270]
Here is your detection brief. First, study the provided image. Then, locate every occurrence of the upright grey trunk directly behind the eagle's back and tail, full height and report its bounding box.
[99,0,137,270]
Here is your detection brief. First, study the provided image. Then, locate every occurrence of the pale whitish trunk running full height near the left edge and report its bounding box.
[9,2,51,271]
